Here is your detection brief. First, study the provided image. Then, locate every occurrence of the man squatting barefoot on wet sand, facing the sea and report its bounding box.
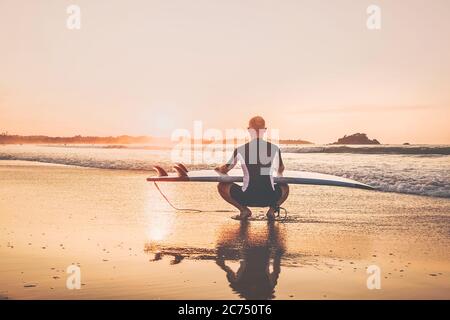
[215,116,289,220]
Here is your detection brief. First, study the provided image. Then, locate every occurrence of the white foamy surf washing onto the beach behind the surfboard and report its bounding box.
[0,145,450,198]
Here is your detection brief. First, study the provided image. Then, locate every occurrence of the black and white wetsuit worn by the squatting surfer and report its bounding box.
[227,139,283,207]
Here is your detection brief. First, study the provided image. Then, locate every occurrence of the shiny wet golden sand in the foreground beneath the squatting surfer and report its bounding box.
[0,161,450,299]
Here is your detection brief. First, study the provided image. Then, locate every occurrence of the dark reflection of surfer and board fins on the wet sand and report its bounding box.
[145,222,285,299]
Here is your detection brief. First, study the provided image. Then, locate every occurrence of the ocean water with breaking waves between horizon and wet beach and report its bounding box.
[0,145,450,198]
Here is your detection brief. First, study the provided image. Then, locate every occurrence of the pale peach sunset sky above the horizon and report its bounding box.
[0,0,450,144]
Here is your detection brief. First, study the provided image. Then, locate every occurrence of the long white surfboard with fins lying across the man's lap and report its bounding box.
[147,163,374,190]
